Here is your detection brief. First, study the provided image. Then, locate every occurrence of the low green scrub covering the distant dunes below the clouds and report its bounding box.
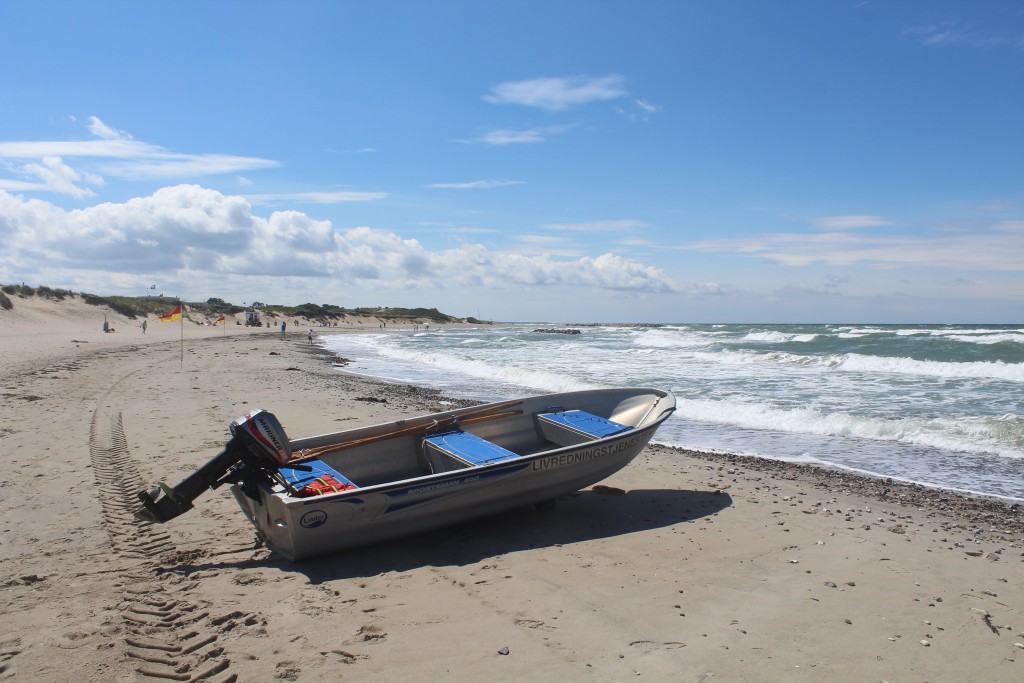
[0,285,464,324]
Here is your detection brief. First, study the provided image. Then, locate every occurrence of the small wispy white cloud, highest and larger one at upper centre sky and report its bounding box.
[483,75,629,112]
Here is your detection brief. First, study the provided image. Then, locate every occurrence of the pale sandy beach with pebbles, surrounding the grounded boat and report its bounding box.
[0,298,1024,683]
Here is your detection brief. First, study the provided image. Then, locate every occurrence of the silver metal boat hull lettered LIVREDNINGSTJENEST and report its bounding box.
[234,389,675,560]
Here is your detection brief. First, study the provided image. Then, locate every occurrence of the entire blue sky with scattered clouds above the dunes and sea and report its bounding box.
[0,0,1024,323]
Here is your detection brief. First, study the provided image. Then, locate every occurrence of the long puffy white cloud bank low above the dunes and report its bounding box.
[0,185,677,294]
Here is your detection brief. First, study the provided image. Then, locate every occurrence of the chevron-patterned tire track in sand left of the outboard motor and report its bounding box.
[89,375,239,683]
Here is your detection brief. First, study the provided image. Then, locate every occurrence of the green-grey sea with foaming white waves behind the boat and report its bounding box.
[319,325,1024,500]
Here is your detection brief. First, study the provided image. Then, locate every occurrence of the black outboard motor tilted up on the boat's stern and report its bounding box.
[135,409,292,522]
